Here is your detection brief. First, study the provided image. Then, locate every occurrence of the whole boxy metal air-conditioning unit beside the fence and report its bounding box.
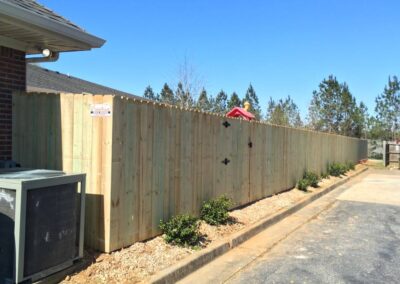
[0,169,85,284]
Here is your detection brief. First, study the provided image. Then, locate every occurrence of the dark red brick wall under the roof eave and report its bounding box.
[0,46,26,160]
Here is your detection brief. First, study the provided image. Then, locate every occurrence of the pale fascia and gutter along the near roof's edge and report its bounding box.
[0,0,105,48]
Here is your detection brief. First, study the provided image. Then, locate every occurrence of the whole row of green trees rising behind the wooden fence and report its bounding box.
[143,75,400,140]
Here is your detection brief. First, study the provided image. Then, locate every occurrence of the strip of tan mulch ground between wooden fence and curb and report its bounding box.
[63,165,365,284]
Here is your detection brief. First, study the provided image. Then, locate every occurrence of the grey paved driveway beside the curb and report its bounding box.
[228,171,400,284]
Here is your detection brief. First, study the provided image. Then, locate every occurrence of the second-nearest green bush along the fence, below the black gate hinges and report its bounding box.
[200,195,232,226]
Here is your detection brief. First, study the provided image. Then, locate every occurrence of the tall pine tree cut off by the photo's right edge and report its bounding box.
[375,76,400,139]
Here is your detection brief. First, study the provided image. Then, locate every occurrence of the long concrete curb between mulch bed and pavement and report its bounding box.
[149,168,368,284]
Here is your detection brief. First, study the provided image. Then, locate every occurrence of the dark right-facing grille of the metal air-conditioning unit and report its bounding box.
[24,184,80,276]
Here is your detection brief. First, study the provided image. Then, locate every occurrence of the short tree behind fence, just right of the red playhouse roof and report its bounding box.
[266,96,303,127]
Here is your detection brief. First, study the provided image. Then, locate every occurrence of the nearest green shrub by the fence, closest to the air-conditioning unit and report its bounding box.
[160,214,200,246]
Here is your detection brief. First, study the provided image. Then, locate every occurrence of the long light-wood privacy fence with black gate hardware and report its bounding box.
[13,93,367,252]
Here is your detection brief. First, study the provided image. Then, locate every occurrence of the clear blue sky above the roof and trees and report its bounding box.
[39,0,400,117]
